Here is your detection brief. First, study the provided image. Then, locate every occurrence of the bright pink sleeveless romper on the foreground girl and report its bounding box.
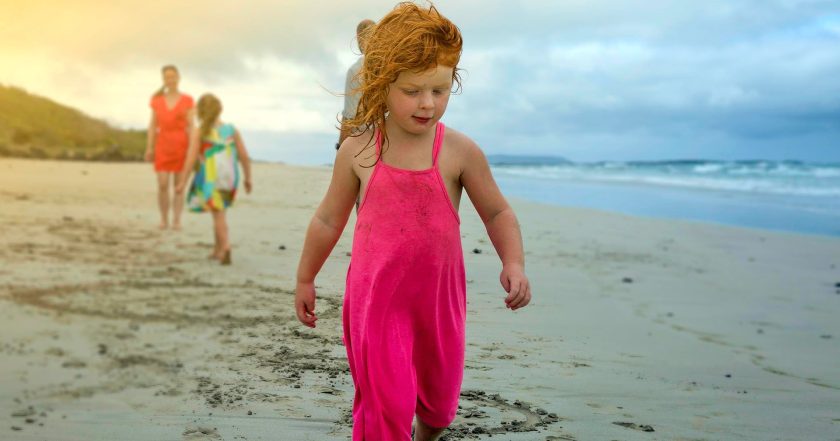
[343,123,466,441]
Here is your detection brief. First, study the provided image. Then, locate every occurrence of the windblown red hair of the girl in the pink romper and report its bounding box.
[344,2,463,152]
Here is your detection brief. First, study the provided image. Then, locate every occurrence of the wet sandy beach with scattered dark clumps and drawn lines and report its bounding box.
[0,159,840,441]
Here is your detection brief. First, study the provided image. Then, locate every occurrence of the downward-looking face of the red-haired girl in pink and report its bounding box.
[385,65,454,135]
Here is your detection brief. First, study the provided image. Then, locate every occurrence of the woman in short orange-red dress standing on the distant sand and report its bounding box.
[146,65,195,230]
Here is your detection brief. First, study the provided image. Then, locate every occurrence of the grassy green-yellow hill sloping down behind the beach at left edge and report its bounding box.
[0,84,146,161]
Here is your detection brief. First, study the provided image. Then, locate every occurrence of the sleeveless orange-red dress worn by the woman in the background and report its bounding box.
[149,93,193,173]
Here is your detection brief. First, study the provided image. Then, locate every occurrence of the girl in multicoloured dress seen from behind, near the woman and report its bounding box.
[178,94,251,265]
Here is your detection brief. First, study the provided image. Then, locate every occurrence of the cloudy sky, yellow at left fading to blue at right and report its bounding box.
[0,0,840,163]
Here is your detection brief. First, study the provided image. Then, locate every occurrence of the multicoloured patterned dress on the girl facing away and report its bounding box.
[187,124,239,212]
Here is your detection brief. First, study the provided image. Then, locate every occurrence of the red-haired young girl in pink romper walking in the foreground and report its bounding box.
[295,3,531,441]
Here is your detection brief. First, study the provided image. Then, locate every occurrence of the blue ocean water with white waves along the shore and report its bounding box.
[490,156,840,236]
